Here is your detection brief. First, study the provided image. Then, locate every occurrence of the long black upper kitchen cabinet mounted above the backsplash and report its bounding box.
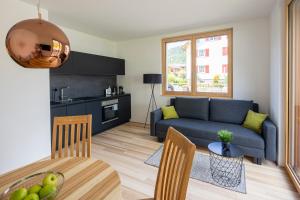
[50,51,125,75]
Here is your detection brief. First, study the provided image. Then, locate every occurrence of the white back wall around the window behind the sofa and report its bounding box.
[117,18,270,122]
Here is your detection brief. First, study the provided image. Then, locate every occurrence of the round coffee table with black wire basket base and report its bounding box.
[208,142,244,187]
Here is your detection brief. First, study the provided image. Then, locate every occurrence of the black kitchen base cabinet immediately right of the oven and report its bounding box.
[119,95,131,123]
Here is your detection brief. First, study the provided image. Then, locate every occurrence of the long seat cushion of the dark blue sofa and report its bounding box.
[155,118,265,149]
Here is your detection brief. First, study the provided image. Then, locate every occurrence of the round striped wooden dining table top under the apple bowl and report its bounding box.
[0,158,121,200]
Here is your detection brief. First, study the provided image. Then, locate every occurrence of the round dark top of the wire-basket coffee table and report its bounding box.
[208,142,243,158]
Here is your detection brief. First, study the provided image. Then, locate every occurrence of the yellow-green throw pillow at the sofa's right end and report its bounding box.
[243,110,268,133]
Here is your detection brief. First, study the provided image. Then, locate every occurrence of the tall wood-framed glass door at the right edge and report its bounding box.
[285,0,300,191]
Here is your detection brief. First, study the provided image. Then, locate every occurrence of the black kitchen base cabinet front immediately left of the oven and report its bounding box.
[85,101,102,134]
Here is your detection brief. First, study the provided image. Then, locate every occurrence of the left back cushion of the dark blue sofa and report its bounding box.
[175,97,209,120]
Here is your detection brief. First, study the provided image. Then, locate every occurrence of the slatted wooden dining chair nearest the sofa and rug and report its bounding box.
[146,127,196,200]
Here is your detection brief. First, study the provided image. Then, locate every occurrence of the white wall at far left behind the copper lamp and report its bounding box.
[0,0,50,173]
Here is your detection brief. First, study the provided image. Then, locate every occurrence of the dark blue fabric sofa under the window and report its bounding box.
[150,97,277,164]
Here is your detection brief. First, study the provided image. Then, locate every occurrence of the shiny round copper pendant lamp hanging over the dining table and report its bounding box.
[5,1,70,68]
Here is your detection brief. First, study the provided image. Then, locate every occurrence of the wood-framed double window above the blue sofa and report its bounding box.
[162,29,232,97]
